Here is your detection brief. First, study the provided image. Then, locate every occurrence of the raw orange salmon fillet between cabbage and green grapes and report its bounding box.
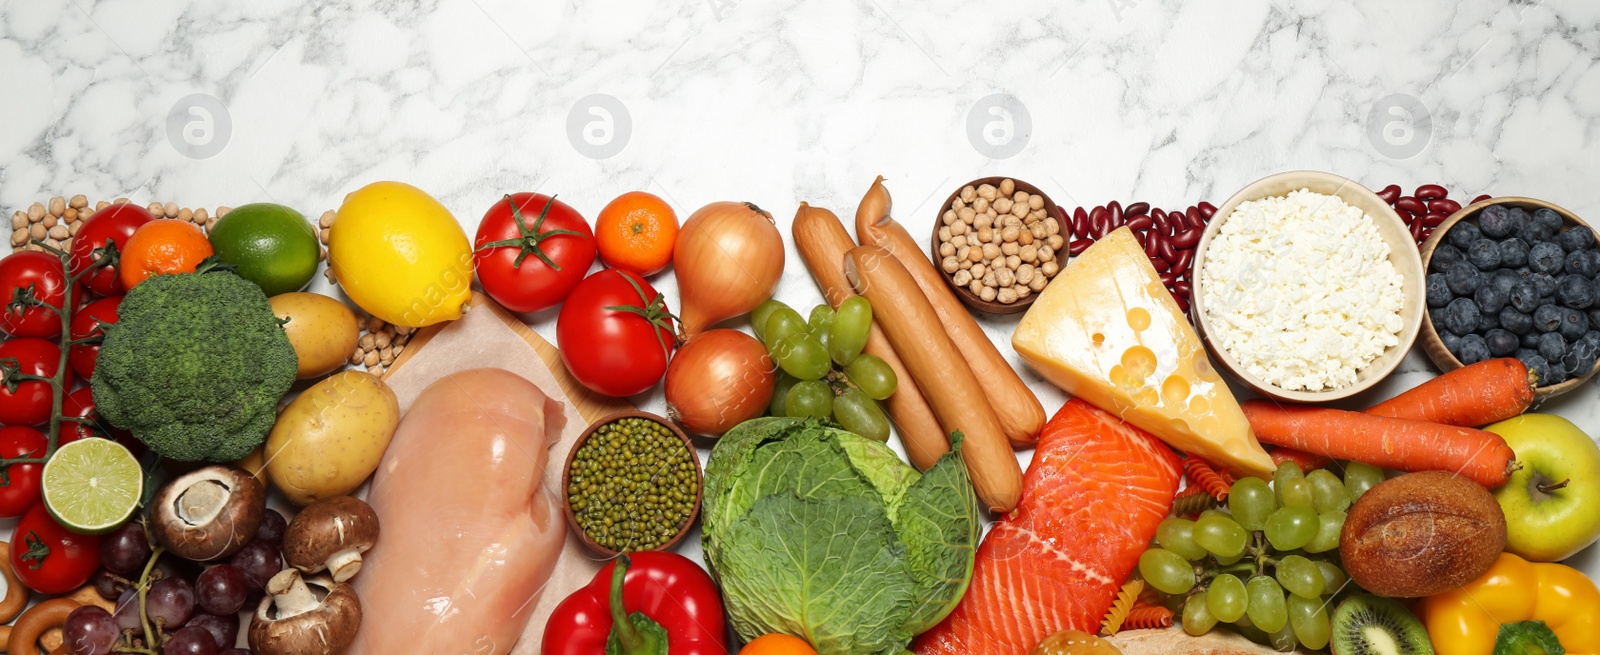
[915,399,1179,655]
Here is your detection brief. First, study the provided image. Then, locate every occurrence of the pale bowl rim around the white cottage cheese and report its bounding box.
[1190,171,1427,402]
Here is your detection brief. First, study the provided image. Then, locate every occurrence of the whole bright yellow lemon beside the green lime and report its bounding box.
[328,183,472,327]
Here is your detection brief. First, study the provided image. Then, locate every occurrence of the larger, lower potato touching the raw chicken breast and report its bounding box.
[266,370,400,504]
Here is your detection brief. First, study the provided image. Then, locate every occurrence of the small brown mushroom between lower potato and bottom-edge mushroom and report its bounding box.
[283,496,378,583]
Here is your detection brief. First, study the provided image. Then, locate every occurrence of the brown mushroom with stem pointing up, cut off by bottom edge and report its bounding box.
[250,569,362,655]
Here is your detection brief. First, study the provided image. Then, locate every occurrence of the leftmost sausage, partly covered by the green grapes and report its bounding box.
[794,202,950,471]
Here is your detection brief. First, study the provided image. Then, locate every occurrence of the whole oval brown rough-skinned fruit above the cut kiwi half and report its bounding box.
[1339,471,1506,597]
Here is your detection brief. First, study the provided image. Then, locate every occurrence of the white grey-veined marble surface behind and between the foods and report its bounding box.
[0,0,1600,637]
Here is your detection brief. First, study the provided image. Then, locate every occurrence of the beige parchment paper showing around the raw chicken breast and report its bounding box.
[386,301,605,655]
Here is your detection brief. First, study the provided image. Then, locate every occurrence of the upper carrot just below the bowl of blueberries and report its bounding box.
[1366,357,1533,428]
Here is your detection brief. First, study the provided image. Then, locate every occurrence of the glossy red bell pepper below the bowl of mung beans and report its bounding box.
[542,553,728,655]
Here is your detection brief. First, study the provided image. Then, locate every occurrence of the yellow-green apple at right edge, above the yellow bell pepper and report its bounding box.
[1486,413,1600,562]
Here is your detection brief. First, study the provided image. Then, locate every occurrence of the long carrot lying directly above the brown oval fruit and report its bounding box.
[1242,400,1517,488]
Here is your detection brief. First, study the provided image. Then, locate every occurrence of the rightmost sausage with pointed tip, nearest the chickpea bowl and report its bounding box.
[856,176,1045,445]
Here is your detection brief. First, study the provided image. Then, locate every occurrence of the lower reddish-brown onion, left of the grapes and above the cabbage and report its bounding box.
[664,330,778,437]
